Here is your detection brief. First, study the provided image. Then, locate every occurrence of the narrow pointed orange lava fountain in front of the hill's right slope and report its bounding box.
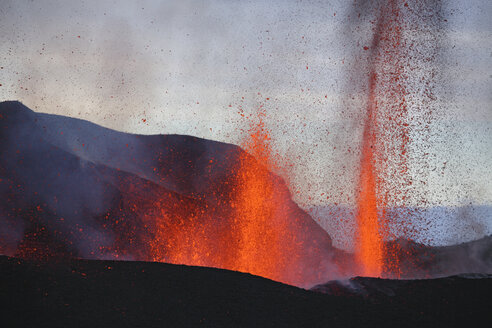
[230,109,295,280]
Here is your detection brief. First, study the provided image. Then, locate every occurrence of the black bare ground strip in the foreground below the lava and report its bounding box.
[0,256,492,327]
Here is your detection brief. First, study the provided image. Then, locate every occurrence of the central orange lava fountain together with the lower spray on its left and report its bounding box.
[147,108,300,283]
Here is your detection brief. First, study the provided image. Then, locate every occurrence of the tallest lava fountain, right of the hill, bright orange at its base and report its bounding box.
[356,0,411,276]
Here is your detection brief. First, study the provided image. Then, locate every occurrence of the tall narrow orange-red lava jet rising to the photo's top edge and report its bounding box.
[356,0,408,276]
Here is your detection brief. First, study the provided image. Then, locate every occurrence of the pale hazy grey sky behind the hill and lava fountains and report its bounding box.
[0,0,492,210]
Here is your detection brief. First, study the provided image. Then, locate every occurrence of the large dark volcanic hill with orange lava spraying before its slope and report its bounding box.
[0,102,340,286]
